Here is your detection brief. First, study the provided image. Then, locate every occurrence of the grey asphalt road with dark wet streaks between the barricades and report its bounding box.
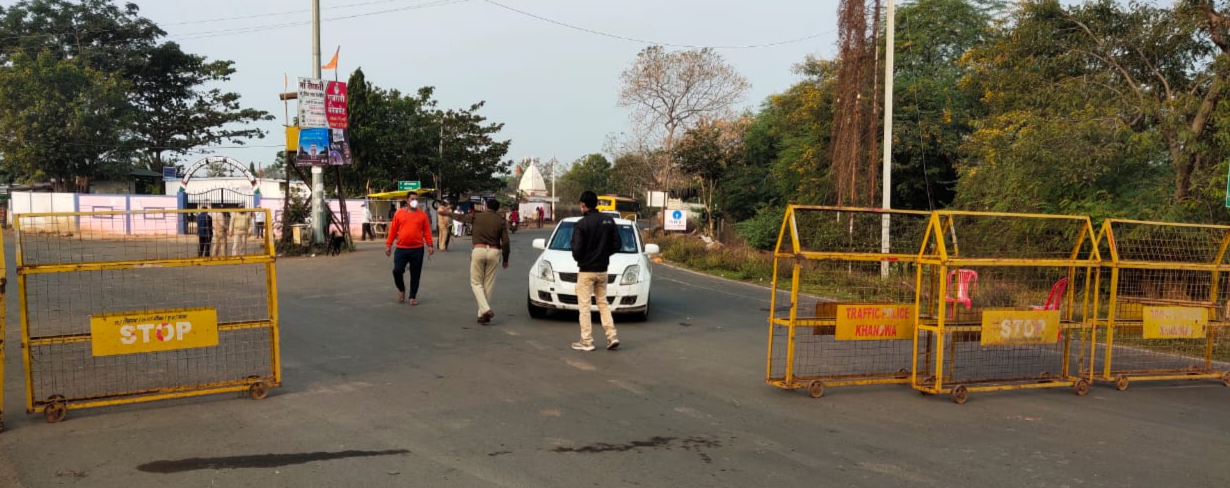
[0,224,1230,481]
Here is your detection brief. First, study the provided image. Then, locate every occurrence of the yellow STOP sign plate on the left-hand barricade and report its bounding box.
[90,309,218,356]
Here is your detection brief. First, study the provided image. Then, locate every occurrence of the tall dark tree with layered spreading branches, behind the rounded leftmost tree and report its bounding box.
[0,0,272,171]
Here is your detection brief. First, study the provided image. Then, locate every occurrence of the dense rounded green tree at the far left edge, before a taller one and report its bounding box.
[0,52,128,192]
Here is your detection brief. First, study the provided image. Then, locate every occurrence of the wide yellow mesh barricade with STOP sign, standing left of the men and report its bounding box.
[14,209,282,422]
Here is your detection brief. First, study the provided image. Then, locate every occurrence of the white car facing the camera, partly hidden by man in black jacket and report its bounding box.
[526,216,659,321]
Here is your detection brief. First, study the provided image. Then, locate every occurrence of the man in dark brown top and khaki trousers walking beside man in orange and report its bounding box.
[460,198,512,325]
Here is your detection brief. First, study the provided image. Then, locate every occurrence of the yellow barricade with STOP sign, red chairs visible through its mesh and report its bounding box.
[910,211,1098,403]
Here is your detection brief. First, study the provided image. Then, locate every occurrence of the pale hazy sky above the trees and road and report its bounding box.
[129,0,838,172]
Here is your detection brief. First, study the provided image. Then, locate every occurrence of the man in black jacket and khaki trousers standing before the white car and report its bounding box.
[572,191,622,352]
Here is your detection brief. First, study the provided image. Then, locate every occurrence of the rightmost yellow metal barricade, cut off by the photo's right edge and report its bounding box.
[1089,219,1230,390]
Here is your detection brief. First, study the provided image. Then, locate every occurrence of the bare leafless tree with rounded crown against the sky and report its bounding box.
[619,45,750,189]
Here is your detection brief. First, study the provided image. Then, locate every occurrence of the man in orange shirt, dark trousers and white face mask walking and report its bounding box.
[385,193,435,305]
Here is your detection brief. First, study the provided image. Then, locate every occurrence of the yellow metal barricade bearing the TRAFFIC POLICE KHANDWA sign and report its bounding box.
[765,205,930,398]
